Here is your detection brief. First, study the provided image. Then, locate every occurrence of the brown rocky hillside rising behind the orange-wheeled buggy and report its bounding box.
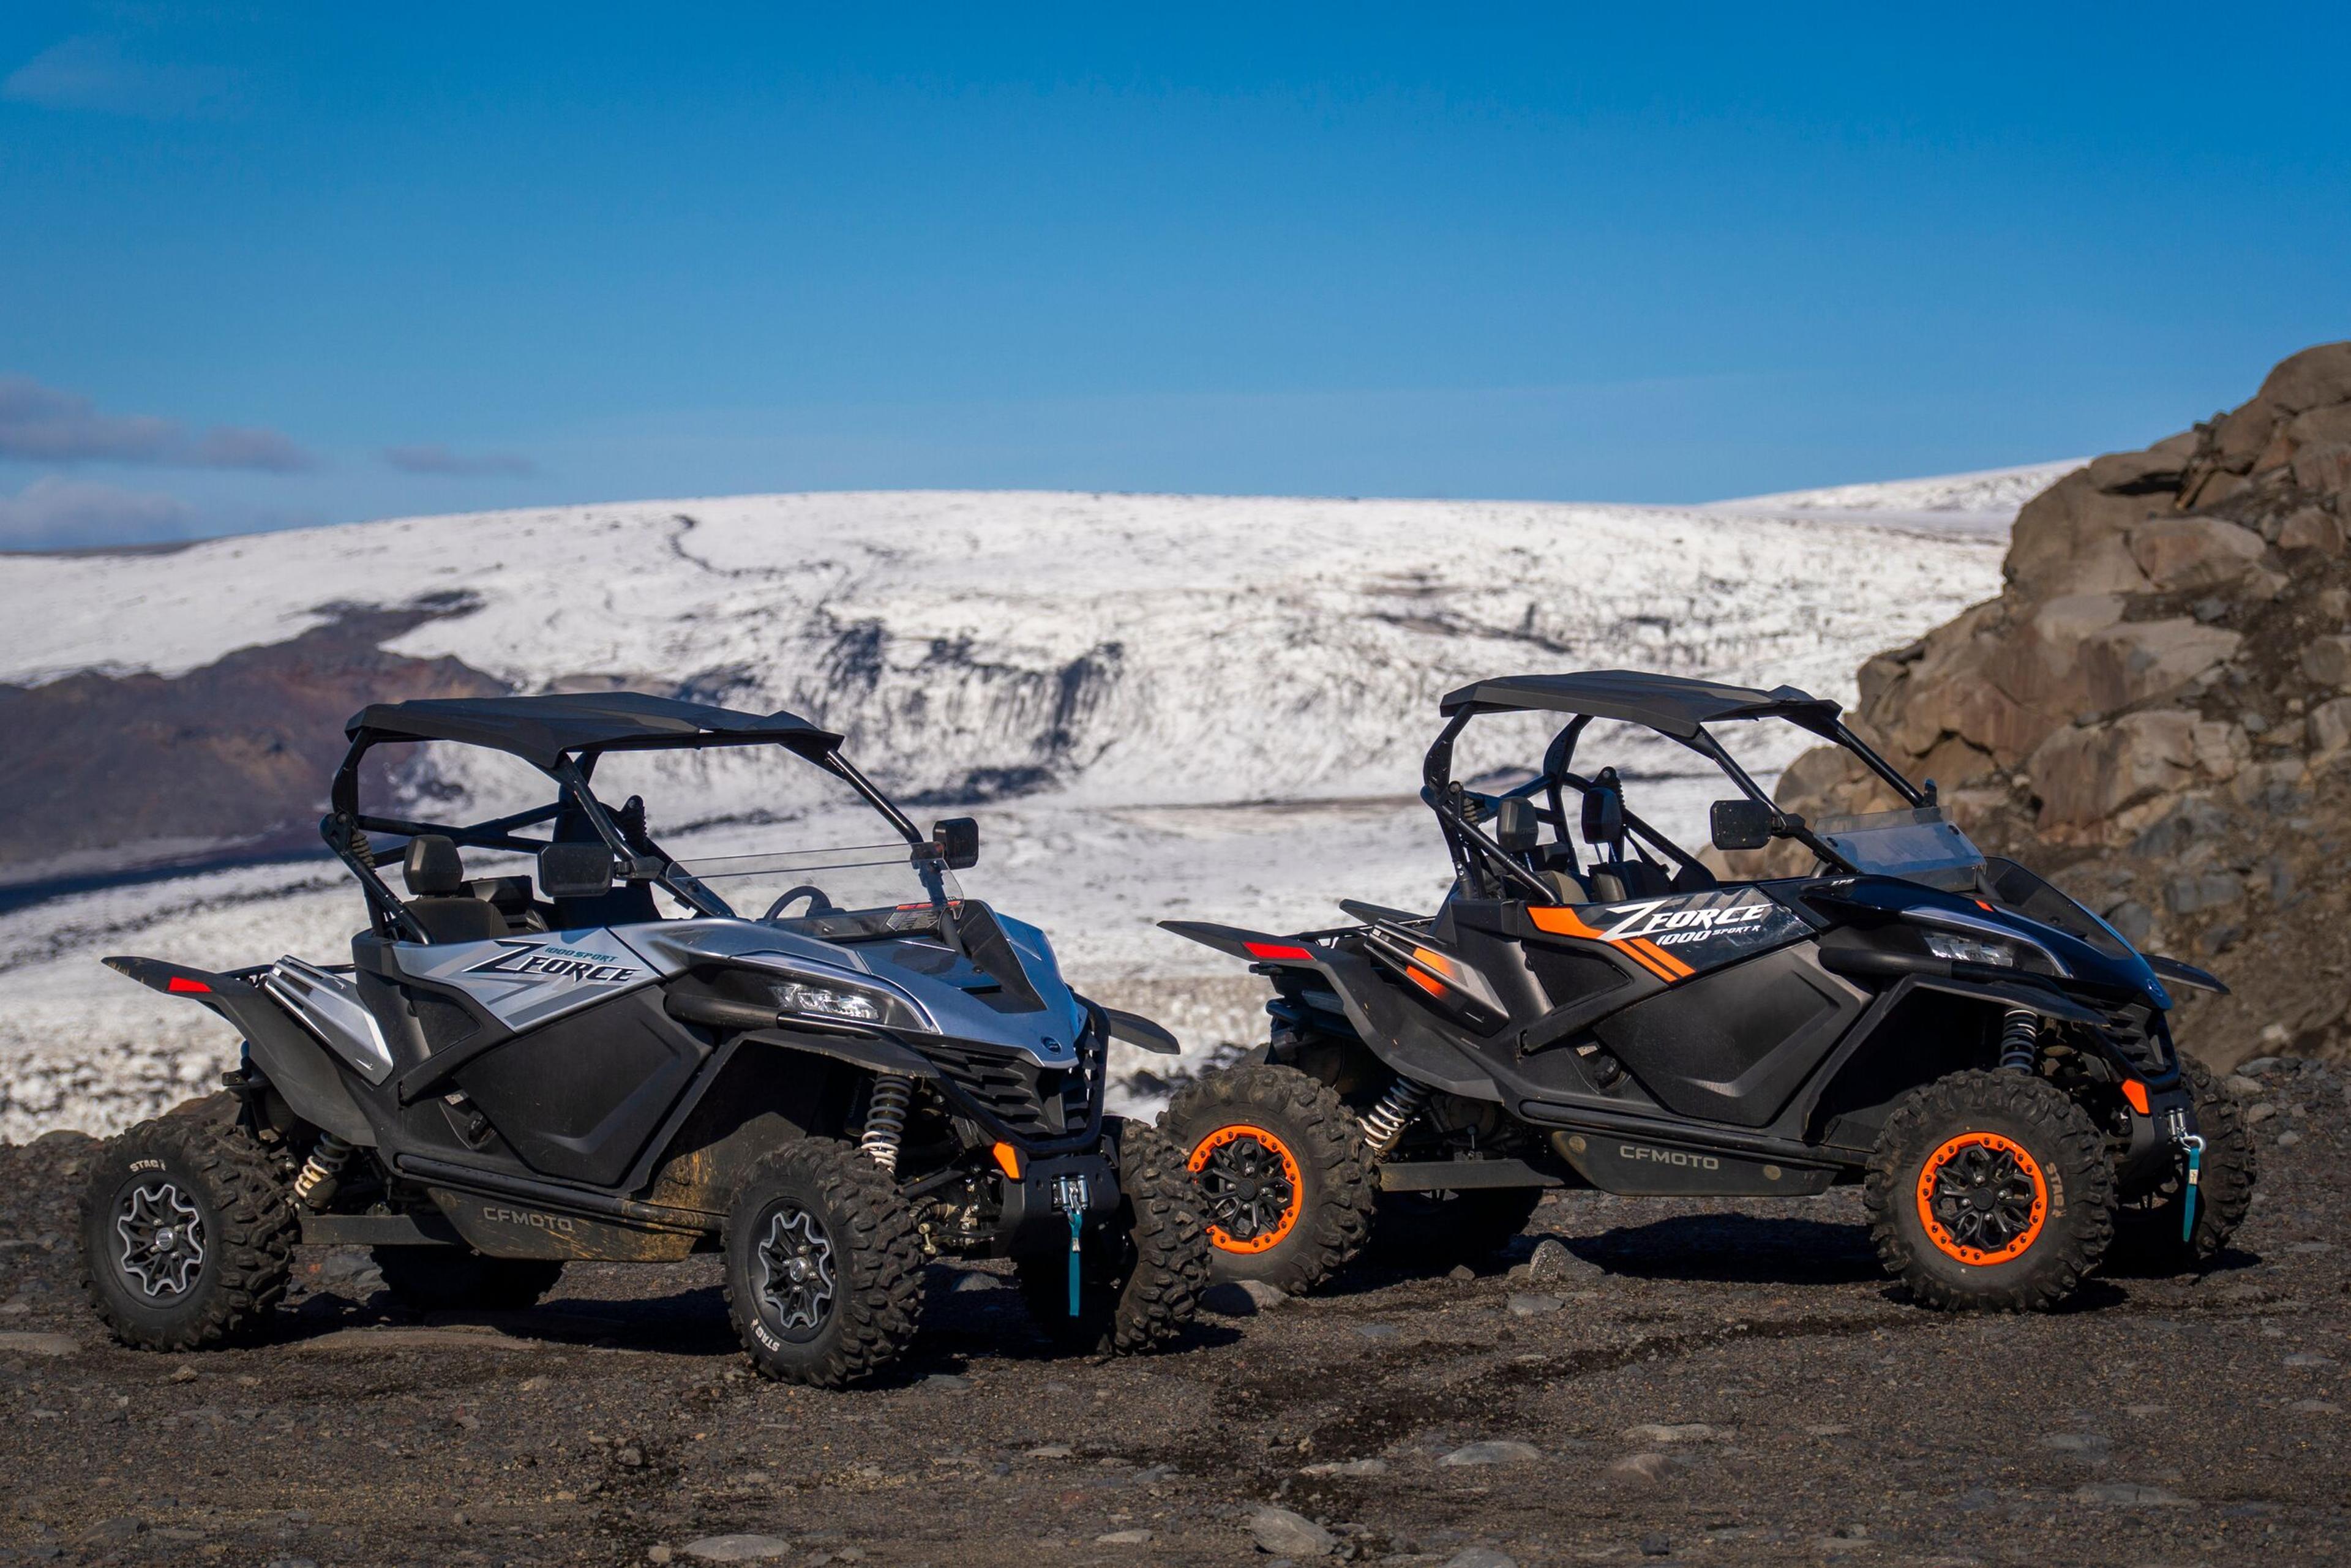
[1777,343,2351,1062]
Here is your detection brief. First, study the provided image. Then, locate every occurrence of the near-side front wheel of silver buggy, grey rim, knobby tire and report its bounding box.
[727,1138,921,1389]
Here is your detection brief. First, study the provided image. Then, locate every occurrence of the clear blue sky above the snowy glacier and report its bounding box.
[0,0,2351,546]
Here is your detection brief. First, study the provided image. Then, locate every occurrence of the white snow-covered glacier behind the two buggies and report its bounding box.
[0,482,2029,1138]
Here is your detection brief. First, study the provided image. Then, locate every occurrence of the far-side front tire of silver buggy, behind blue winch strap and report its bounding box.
[1013,1117,1209,1356]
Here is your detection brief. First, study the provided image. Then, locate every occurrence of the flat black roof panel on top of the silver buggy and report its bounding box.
[343,691,842,769]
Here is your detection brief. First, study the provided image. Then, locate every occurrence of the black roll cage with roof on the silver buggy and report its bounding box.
[320,691,933,940]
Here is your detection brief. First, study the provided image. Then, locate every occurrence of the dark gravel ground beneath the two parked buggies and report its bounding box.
[0,1062,2351,1568]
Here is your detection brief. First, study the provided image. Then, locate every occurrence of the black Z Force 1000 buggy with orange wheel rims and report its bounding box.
[1161,670,2255,1310]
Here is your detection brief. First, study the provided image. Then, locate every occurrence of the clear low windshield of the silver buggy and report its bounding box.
[672,839,962,936]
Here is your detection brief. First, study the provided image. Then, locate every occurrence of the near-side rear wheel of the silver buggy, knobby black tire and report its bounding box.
[80,1114,296,1349]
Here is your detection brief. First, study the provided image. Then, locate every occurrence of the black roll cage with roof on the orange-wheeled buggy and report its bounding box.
[1420,670,1935,905]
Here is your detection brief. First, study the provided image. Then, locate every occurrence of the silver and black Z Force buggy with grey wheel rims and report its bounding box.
[82,694,1209,1387]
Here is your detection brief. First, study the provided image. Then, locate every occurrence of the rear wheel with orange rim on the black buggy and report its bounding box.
[1159,1062,1373,1293]
